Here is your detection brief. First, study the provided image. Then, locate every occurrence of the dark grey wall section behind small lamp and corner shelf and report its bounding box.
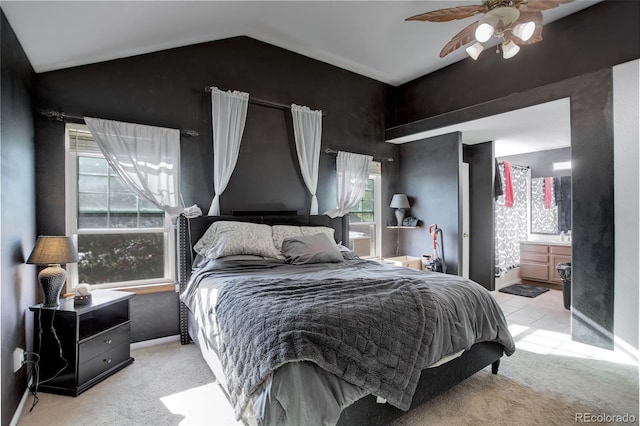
[399,132,462,275]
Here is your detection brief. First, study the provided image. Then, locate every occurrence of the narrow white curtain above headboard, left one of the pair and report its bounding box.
[208,87,249,216]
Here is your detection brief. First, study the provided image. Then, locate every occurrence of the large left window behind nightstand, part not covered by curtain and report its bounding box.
[66,124,174,287]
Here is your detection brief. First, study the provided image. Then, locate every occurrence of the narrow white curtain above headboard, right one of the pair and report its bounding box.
[291,104,322,215]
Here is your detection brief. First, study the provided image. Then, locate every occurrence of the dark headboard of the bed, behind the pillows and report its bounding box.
[176,213,349,345]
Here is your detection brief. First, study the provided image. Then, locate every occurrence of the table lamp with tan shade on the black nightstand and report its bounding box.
[27,236,78,308]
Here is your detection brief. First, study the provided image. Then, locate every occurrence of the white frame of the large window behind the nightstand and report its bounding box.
[65,123,176,291]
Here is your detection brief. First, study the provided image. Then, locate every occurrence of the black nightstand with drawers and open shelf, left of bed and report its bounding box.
[29,290,135,396]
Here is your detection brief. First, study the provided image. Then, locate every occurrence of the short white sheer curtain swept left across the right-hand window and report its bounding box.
[325,151,373,218]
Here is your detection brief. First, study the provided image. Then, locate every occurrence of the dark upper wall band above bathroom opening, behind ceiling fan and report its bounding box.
[395,0,640,125]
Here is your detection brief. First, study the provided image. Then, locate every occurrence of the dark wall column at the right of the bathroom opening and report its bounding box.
[571,70,614,349]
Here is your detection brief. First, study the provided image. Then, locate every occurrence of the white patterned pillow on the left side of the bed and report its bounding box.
[193,221,282,259]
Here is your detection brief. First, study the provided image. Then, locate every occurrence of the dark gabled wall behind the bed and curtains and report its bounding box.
[36,37,397,341]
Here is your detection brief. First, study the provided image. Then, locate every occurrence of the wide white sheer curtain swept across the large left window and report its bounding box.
[84,117,202,218]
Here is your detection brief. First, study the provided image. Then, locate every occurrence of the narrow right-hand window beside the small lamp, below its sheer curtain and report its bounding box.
[349,161,382,257]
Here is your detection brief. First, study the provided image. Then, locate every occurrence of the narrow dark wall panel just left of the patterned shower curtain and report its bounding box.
[464,142,495,290]
